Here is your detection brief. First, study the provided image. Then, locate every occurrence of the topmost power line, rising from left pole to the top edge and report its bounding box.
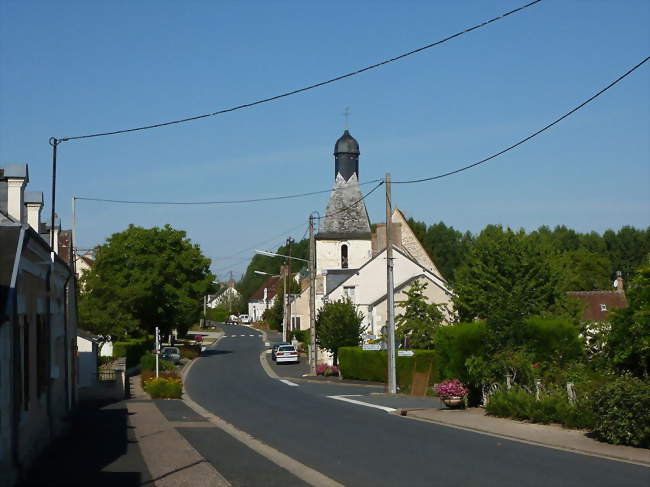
[55,0,542,142]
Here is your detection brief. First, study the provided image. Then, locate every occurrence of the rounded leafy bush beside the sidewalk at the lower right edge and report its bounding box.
[593,375,650,448]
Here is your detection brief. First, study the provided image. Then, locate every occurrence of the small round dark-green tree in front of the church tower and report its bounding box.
[316,299,364,365]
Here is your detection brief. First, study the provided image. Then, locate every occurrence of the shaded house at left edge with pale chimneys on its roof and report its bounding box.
[0,164,77,485]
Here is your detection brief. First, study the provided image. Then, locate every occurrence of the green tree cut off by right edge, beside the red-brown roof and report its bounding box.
[607,256,650,377]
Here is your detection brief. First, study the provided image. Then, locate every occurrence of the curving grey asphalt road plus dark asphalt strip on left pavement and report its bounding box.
[185,325,650,487]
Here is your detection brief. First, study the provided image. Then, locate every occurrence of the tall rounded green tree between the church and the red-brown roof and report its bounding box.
[454,225,557,345]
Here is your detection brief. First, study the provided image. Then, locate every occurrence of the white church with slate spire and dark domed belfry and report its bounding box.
[291,130,453,346]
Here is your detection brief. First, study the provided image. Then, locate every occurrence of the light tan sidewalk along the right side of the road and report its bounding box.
[397,408,650,467]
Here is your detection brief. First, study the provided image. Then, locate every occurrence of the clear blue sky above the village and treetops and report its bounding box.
[0,0,650,279]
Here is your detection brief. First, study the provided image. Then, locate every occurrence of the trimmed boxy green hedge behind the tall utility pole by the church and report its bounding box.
[338,347,439,389]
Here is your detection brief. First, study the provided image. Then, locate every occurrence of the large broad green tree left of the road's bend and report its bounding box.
[80,225,214,340]
